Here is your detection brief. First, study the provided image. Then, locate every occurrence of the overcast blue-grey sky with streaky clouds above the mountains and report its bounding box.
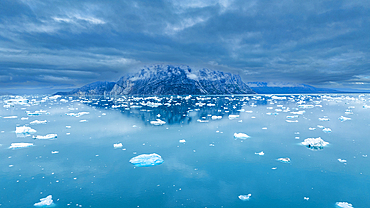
[0,0,370,93]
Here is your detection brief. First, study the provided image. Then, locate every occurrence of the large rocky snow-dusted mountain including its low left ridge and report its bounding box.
[57,65,255,96]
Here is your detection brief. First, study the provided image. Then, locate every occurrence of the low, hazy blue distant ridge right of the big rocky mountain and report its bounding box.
[247,82,341,94]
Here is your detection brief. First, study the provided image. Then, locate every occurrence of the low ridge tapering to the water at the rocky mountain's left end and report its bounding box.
[56,81,116,96]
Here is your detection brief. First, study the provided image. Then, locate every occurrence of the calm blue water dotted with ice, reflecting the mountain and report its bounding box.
[0,94,370,208]
